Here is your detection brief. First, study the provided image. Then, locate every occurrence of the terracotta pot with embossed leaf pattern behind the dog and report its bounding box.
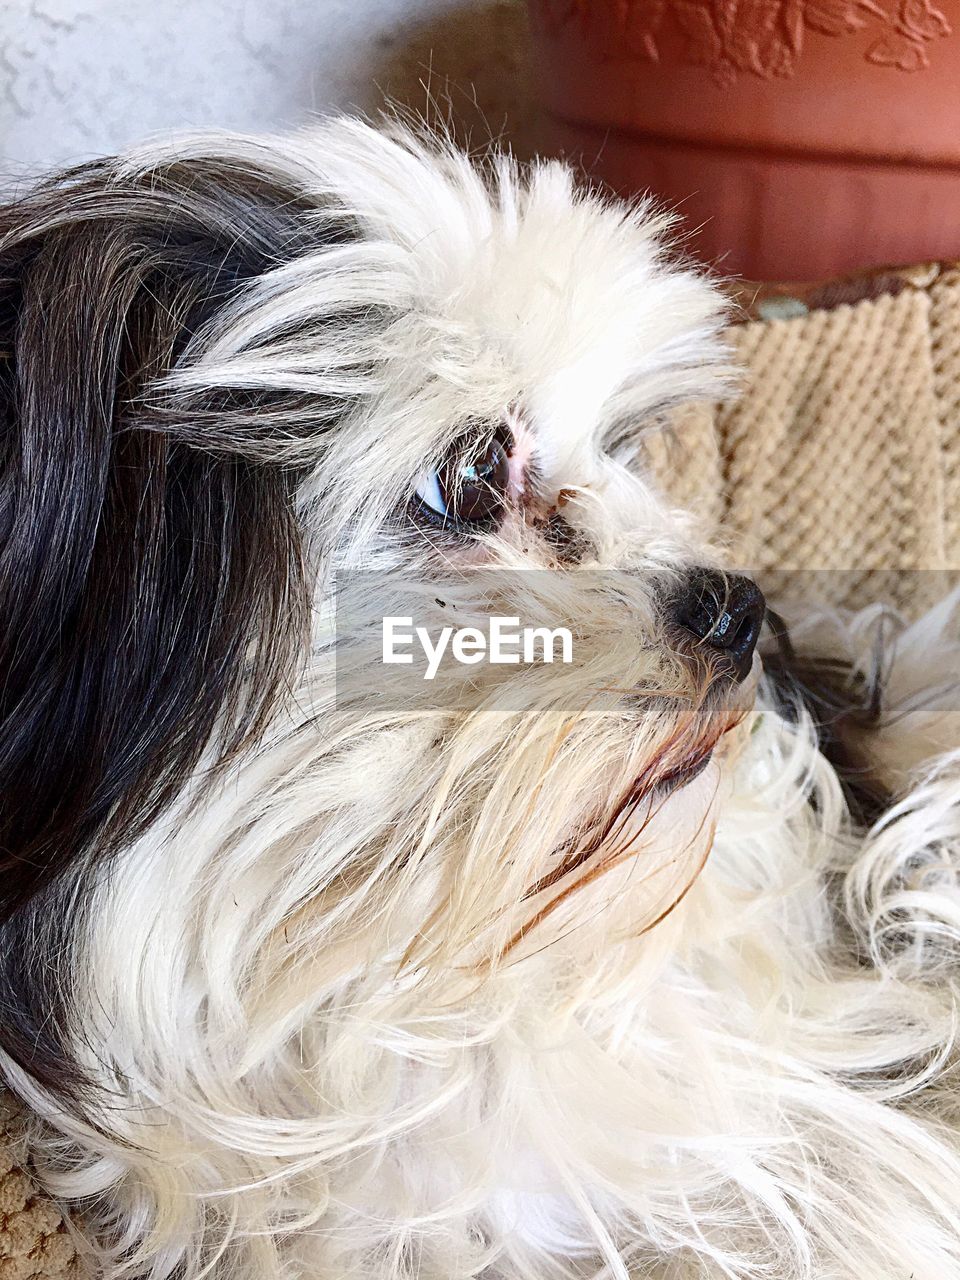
[530,0,960,280]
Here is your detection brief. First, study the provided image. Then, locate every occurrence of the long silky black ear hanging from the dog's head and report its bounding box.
[0,159,347,920]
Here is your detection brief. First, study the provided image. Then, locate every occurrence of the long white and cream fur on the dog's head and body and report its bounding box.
[10,122,960,1280]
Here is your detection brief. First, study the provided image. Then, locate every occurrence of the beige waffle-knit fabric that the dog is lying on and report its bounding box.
[0,259,960,1280]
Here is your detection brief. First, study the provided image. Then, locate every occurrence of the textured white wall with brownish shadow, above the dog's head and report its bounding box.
[0,0,534,177]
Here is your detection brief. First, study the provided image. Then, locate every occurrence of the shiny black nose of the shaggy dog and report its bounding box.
[675,568,767,681]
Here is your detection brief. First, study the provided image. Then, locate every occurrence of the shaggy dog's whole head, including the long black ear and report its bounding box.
[0,123,762,1269]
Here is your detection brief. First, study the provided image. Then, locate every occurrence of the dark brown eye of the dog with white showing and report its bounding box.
[416,428,512,530]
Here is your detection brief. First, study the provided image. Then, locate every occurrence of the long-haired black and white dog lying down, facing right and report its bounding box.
[0,119,960,1280]
